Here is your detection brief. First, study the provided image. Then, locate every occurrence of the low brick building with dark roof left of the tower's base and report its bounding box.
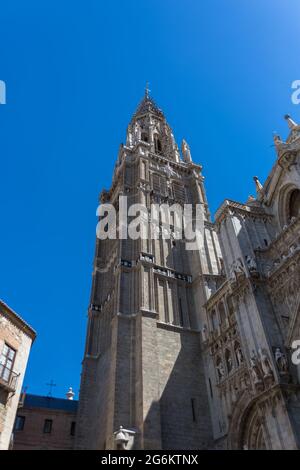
[13,394,78,450]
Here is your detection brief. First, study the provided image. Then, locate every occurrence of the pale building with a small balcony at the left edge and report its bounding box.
[0,300,36,450]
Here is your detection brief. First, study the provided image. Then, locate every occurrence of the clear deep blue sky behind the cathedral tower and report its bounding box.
[0,0,300,396]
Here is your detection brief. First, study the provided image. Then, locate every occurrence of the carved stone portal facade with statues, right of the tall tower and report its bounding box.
[202,116,300,449]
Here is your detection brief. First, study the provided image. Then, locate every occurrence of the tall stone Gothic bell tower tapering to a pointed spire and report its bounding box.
[76,91,222,449]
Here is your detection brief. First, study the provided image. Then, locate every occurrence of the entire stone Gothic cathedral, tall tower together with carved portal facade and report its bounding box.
[75,91,300,450]
